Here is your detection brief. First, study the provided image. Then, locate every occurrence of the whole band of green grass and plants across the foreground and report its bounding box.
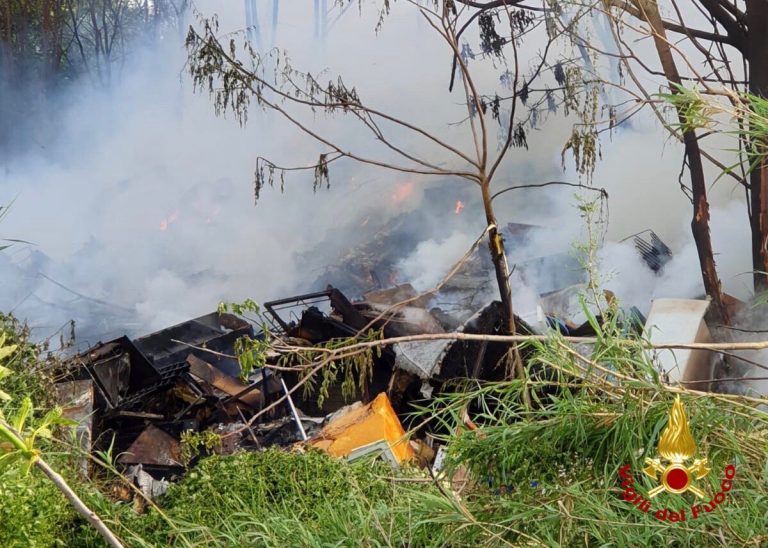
[0,310,768,547]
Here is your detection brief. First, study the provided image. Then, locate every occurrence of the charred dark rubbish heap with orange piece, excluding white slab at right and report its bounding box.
[56,276,544,504]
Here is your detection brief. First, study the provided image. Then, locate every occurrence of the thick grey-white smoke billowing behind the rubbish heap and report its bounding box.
[0,0,749,352]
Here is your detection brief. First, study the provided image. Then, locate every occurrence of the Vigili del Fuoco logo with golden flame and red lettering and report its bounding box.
[619,396,736,522]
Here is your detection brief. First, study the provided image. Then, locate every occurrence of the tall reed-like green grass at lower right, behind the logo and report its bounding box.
[426,338,768,546]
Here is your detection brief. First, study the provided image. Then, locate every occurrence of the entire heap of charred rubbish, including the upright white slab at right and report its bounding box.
[56,225,756,497]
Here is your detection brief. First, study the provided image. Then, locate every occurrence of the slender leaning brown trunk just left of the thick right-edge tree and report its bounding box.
[637,0,730,324]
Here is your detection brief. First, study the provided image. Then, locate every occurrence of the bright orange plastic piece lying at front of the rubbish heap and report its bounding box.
[310,392,415,463]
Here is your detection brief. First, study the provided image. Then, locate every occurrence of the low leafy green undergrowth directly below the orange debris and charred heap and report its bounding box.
[80,449,452,546]
